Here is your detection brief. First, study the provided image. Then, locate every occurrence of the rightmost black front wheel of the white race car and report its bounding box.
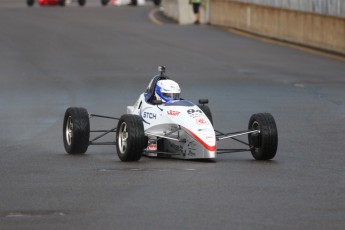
[248,113,278,160]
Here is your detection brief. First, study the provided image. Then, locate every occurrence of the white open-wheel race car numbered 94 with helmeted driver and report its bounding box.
[63,66,278,161]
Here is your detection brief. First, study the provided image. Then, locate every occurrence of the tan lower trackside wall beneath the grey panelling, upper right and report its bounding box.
[210,0,345,54]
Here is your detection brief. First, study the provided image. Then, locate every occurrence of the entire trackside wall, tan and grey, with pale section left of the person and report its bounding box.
[163,0,345,55]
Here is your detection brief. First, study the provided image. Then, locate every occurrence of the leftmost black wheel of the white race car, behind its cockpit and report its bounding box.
[63,107,90,154]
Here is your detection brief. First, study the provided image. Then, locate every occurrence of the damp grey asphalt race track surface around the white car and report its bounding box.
[0,0,345,230]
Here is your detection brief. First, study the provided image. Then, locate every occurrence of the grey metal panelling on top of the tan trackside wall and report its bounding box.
[233,0,345,18]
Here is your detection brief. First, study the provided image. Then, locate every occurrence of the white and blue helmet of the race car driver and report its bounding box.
[155,79,181,102]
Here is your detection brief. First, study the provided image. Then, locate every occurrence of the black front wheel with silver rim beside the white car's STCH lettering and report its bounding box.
[116,114,147,161]
